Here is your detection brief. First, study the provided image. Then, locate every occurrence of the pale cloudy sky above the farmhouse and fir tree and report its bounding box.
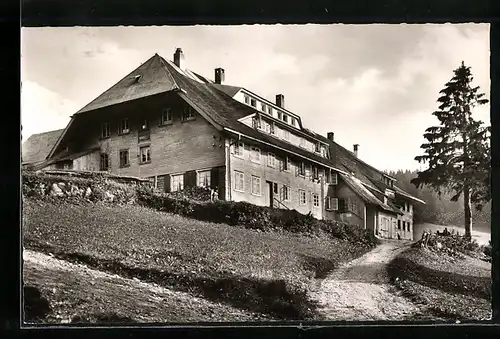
[21,24,490,170]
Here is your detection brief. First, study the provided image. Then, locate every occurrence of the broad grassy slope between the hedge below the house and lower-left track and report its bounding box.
[23,199,368,319]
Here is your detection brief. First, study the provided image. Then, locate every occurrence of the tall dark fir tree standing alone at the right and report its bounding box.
[411,61,491,239]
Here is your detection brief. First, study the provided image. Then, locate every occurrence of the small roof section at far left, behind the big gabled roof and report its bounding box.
[22,129,64,164]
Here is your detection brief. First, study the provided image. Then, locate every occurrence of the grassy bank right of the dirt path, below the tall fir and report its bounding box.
[389,248,492,321]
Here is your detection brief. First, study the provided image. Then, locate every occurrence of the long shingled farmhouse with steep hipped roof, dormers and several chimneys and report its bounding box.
[23,48,423,239]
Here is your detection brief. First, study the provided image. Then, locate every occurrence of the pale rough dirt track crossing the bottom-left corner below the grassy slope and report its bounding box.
[23,250,263,323]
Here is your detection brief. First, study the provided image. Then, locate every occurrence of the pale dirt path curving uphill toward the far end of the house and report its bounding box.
[311,241,422,321]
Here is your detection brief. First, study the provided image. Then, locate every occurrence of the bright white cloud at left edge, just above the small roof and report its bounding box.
[21,81,78,141]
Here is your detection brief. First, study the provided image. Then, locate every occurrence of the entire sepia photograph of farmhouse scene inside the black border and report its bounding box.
[21,23,492,327]
